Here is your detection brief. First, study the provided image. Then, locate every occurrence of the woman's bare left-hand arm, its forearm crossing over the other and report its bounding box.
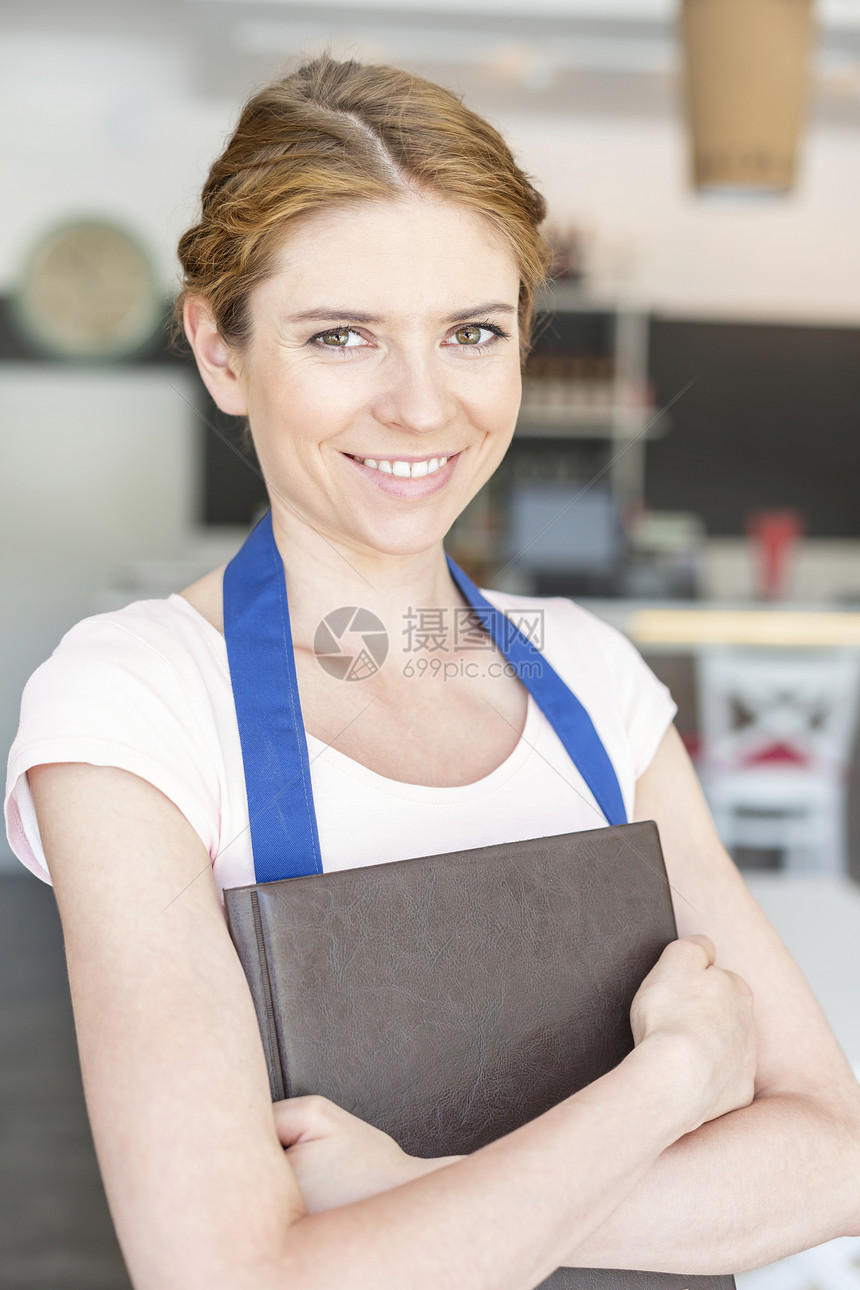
[30,764,752,1290]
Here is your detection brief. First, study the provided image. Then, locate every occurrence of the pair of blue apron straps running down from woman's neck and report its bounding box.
[223,511,627,882]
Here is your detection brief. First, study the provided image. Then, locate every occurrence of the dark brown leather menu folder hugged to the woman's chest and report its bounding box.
[224,822,734,1290]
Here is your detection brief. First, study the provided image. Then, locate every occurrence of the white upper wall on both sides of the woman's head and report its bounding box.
[0,34,860,321]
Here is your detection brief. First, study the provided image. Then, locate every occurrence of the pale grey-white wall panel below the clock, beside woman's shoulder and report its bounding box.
[0,364,199,867]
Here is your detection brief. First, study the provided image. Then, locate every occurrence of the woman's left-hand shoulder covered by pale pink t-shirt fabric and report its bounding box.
[5,580,235,877]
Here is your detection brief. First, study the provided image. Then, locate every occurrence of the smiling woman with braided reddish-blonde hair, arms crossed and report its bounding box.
[8,58,860,1290]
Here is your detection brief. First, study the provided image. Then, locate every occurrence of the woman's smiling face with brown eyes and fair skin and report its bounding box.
[219,195,521,553]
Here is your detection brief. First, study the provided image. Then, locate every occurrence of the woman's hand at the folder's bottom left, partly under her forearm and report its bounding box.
[272,1097,447,1214]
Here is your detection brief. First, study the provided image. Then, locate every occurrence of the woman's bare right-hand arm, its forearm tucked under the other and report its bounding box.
[559,728,860,1273]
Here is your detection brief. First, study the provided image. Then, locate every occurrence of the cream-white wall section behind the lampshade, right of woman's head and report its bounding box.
[509,119,860,323]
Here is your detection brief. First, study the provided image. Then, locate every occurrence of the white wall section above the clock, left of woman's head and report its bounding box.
[0,34,215,299]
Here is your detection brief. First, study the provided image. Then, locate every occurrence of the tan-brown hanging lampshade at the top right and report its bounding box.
[681,0,814,194]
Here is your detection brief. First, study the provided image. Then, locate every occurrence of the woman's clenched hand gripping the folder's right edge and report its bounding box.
[630,934,757,1131]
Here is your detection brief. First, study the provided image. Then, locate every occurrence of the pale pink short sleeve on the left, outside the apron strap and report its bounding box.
[4,614,219,882]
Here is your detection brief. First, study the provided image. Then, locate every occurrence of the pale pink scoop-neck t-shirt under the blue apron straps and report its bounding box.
[5,591,676,908]
